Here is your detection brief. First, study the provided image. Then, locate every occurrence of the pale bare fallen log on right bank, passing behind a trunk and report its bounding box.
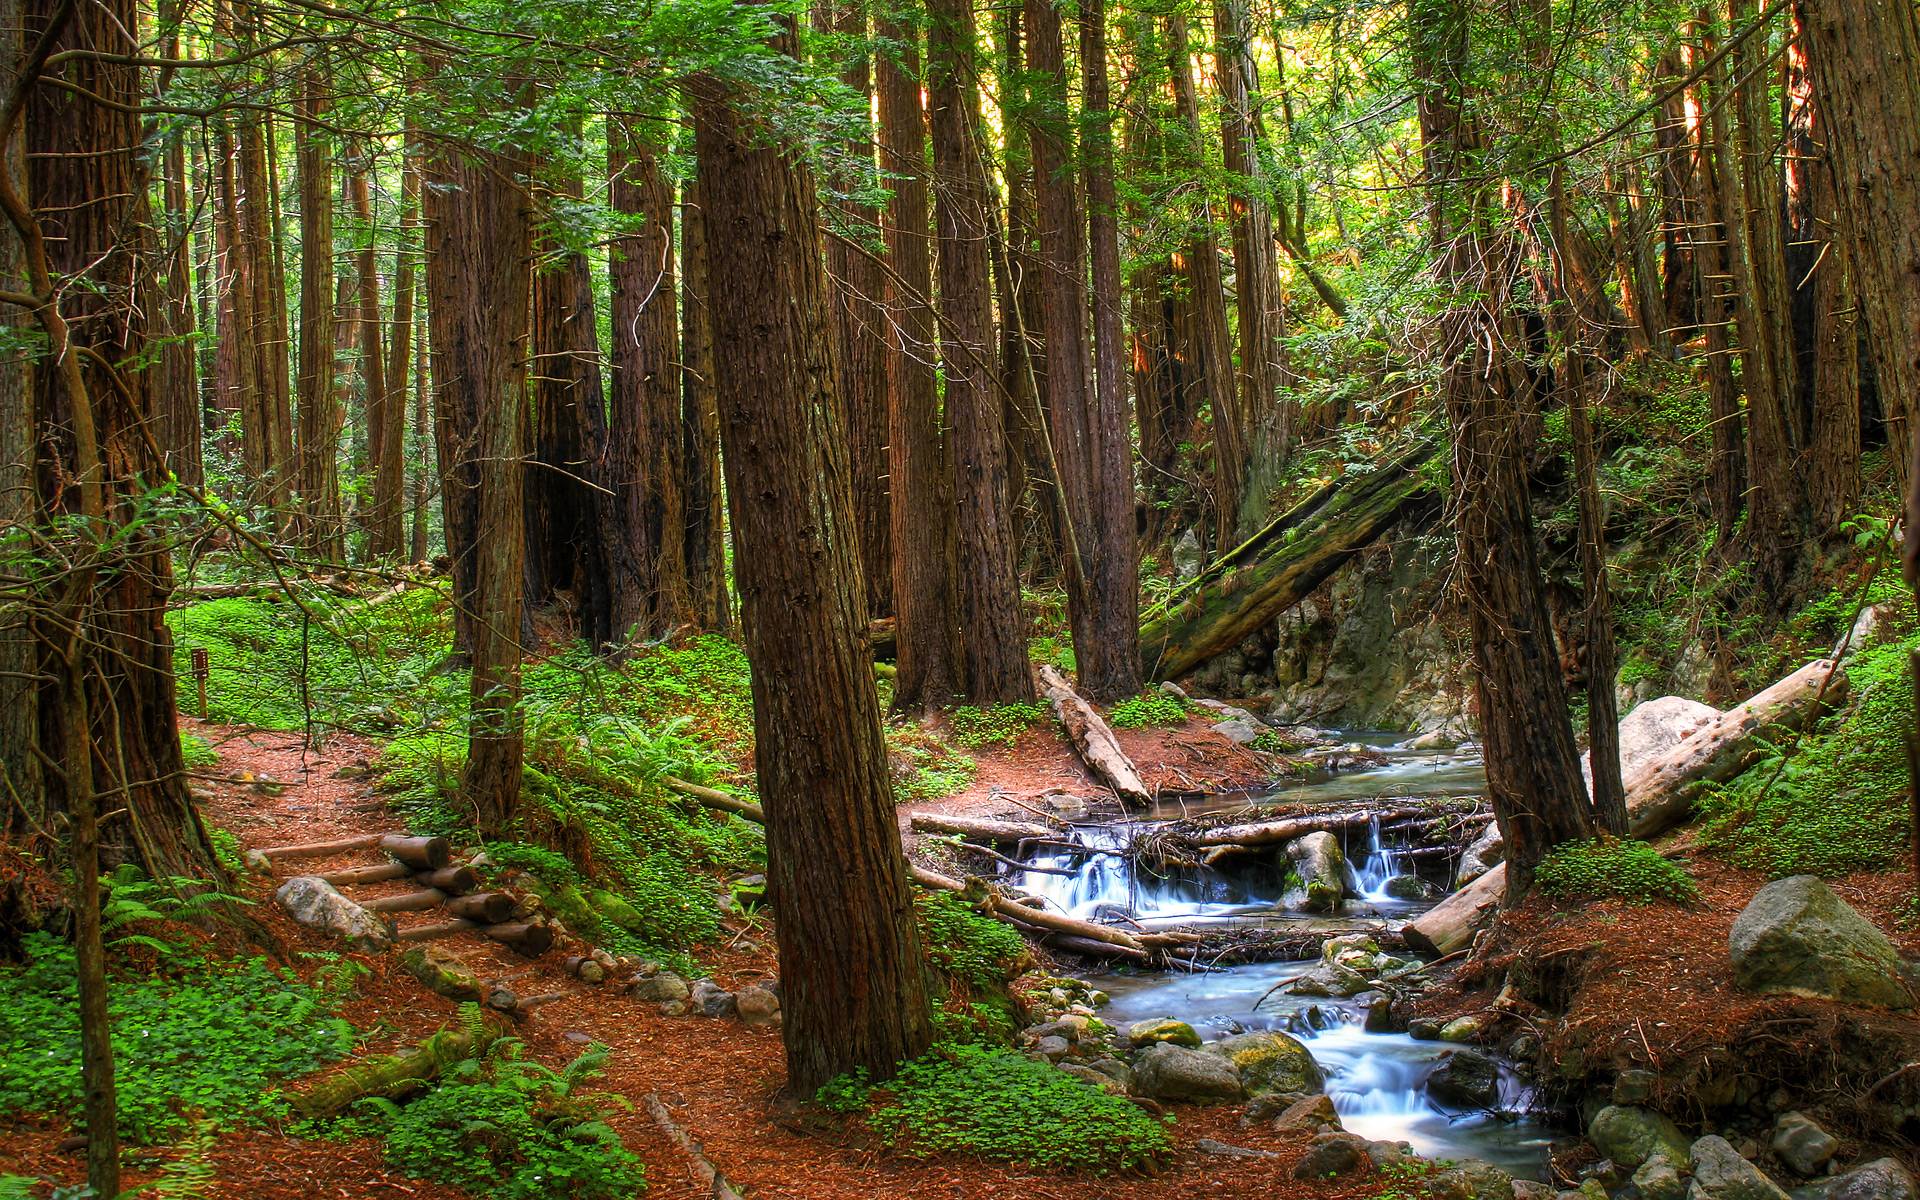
[1402,659,1847,954]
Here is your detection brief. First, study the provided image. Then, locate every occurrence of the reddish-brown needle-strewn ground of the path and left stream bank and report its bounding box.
[0,722,1380,1200]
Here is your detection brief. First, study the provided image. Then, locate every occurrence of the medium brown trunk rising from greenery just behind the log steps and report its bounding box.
[422,144,532,835]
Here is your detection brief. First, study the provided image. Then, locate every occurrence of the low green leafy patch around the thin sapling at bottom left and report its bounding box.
[0,933,353,1142]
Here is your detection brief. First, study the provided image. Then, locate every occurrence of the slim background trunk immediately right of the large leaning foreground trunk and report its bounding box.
[814,0,894,618]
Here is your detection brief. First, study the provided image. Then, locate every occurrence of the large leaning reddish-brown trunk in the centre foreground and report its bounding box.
[691,31,933,1096]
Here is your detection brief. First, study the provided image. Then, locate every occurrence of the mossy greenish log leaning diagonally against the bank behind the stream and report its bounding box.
[1140,444,1434,680]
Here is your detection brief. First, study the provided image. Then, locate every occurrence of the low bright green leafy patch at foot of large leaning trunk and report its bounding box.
[860,1043,1171,1173]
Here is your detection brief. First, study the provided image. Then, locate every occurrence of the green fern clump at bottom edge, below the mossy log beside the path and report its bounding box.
[357,1039,647,1200]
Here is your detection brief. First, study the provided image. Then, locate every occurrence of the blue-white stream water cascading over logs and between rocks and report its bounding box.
[1014,735,1551,1179]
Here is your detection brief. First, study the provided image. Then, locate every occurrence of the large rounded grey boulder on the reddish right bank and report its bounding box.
[1728,876,1914,1008]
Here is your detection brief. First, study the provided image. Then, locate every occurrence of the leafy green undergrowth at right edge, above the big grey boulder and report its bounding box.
[1699,599,1920,876]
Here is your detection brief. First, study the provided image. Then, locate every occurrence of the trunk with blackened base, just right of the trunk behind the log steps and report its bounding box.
[520,144,624,647]
